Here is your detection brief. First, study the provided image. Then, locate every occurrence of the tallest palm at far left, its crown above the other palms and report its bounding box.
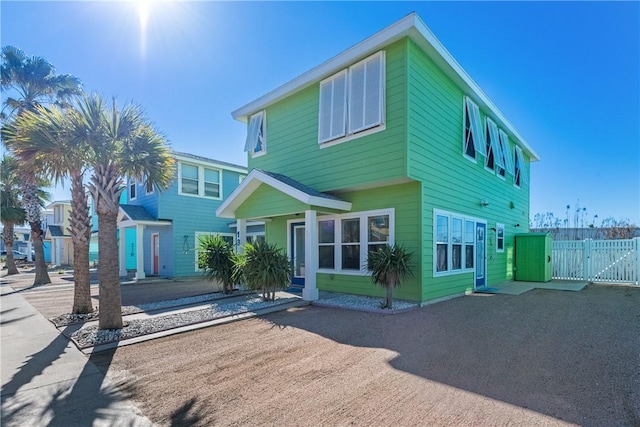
[0,46,82,285]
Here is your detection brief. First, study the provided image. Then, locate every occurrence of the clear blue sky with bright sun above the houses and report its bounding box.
[0,0,640,225]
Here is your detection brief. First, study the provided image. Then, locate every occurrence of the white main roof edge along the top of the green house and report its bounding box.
[231,12,540,161]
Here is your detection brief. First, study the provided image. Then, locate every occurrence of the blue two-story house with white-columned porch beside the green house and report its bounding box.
[118,151,264,279]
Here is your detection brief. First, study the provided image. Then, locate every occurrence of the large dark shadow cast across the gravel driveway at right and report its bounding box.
[266,285,640,426]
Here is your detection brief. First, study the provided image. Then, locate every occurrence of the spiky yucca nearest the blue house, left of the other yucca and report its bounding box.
[198,235,236,294]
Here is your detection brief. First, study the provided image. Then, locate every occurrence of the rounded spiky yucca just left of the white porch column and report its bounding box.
[235,241,292,301]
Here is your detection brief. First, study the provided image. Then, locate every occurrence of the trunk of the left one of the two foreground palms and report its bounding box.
[69,172,93,314]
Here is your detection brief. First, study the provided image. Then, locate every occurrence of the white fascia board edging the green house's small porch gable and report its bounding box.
[216,169,351,218]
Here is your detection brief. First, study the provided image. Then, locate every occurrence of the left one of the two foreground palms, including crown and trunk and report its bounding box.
[5,106,93,314]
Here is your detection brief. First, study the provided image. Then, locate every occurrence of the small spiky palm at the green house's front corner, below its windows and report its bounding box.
[365,244,413,308]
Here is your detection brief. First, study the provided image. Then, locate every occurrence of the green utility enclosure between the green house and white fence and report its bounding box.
[515,233,553,282]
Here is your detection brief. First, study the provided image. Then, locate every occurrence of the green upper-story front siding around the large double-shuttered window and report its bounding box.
[249,40,406,191]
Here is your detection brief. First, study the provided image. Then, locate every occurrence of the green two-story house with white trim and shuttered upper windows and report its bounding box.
[217,10,538,303]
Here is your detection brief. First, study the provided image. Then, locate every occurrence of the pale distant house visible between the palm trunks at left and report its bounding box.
[44,200,73,266]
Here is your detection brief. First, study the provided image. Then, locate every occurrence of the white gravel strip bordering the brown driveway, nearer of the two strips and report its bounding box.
[71,297,298,348]
